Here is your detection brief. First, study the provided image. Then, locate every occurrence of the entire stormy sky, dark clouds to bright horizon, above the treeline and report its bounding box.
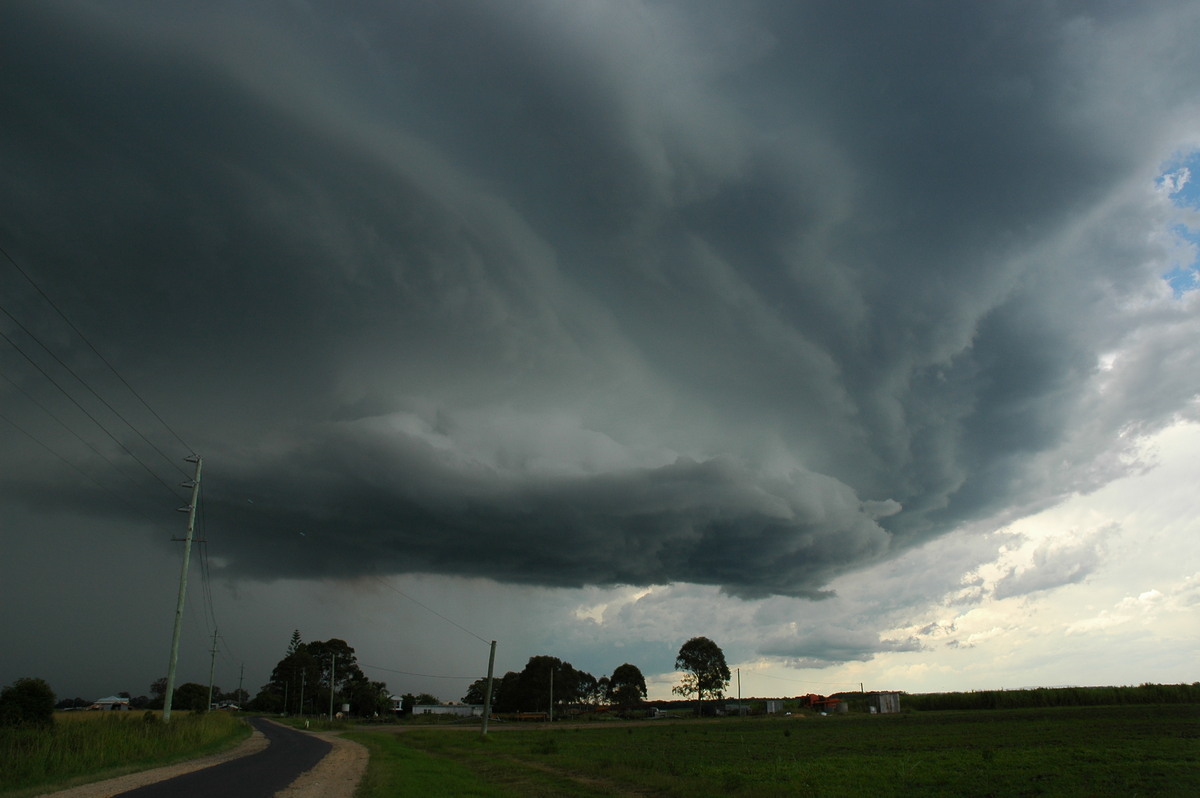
[0,0,1200,700]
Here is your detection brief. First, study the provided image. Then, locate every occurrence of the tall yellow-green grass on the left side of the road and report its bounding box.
[0,712,251,794]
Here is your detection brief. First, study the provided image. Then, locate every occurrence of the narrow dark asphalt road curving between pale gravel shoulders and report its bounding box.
[121,718,332,798]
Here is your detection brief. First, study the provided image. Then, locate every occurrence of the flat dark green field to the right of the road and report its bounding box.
[349,704,1200,798]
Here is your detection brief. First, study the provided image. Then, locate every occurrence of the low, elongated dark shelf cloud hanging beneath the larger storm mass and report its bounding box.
[196,431,887,595]
